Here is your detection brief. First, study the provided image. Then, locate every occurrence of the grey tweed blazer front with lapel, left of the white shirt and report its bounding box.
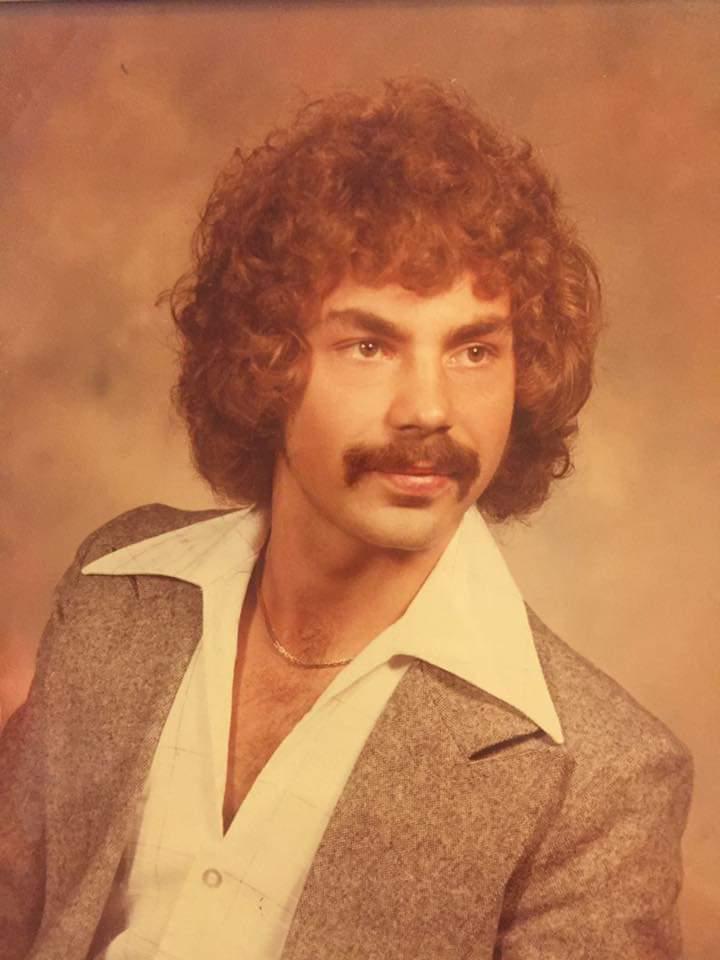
[43,576,202,956]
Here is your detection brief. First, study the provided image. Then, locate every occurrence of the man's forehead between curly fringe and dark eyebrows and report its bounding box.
[320,275,510,332]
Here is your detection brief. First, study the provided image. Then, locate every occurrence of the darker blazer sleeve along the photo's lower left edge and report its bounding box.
[0,535,95,960]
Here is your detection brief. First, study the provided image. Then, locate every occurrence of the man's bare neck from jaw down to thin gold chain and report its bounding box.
[261,488,452,660]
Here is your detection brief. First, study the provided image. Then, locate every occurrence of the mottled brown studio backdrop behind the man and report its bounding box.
[0,2,720,960]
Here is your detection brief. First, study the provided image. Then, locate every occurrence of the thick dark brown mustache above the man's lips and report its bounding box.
[343,434,480,500]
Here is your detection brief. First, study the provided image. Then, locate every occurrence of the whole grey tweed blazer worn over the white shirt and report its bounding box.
[0,505,691,960]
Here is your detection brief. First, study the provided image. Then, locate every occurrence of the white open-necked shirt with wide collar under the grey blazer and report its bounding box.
[83,509,562,960]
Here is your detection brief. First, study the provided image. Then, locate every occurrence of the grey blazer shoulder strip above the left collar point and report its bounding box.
[78,503,232,564]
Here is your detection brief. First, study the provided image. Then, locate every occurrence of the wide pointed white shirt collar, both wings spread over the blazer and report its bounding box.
[83,509,563,743]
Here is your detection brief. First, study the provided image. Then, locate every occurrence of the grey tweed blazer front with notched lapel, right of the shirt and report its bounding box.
[283,662,568,960]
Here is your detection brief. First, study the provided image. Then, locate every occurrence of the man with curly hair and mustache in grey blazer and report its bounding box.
[0,82,690,960]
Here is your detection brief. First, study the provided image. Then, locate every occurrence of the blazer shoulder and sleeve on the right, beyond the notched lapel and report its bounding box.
[501,613,692,960]
